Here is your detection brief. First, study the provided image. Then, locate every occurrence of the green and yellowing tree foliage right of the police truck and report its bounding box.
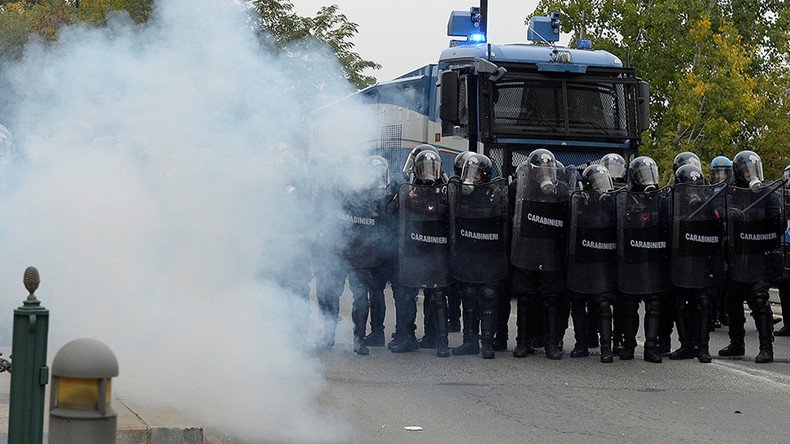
[536,0,790,177]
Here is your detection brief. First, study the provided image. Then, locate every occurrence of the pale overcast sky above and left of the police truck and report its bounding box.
[293,0,538,81]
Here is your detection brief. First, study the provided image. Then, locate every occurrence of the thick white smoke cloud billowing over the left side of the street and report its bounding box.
[0,0,380,441]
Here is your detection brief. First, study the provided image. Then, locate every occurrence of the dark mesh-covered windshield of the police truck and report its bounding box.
[492,78,633,138]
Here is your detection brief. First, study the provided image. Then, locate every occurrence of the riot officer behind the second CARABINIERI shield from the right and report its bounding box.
[669,163,726,363]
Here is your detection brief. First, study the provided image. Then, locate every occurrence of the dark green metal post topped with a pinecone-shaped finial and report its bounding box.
[8,267,49,444]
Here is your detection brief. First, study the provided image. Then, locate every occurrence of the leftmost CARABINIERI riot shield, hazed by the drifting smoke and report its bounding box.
[337,190,384,268]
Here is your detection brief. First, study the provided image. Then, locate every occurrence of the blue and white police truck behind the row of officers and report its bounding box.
[310,0,650,175]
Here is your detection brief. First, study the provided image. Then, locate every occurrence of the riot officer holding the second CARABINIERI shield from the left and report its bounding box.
[391,150,452,357]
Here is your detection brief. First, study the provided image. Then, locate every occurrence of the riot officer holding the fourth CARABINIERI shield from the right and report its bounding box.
[567,165,617,363]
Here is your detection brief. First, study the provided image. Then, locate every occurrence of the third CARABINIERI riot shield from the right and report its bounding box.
[617,188,672,294]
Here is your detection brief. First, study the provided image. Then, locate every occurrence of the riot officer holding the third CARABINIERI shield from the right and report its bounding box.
[617,156,671,363]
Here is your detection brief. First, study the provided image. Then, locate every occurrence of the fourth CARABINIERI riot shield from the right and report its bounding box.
[567,191,617,294]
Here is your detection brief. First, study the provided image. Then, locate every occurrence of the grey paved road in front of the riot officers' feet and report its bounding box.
[318,295,790,443]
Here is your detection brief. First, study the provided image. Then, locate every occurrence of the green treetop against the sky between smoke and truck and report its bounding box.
[251,0,381,89]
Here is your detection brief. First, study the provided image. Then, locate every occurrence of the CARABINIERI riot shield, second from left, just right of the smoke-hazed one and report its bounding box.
[398,184,452,288]
